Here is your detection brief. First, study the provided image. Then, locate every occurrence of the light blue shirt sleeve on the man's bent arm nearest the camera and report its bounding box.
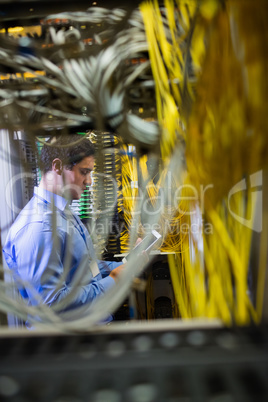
[9,223,115,311]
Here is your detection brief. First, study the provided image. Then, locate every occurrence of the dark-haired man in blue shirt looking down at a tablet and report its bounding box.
[3,135,123,321]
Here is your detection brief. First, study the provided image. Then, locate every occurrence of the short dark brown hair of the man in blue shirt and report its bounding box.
[40,134,95,173]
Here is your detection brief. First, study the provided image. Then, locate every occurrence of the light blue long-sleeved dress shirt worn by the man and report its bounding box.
[3,187,121,321]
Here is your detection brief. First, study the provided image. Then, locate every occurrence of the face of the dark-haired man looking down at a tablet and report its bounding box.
[62,156,95,200]
